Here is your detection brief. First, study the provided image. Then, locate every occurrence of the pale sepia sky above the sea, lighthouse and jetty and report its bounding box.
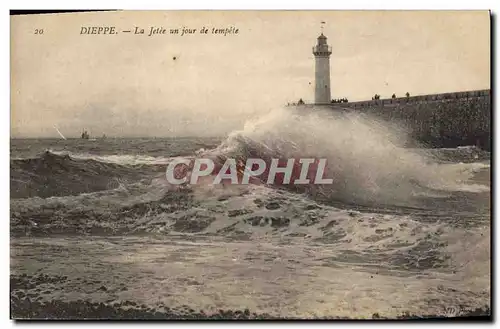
[11,11,490,138]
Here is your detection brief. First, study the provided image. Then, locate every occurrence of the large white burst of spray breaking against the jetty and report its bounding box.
[191,108,489,204]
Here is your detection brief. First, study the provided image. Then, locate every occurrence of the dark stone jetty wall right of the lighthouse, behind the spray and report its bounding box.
[338,90,492,151]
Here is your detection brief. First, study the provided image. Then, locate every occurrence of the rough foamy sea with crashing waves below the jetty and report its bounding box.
[10,108,491,318]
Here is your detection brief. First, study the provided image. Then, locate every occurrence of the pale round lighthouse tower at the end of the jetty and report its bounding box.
[313,32,332,104]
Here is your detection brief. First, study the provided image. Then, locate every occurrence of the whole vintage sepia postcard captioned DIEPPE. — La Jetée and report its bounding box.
[10,11,492,320]
